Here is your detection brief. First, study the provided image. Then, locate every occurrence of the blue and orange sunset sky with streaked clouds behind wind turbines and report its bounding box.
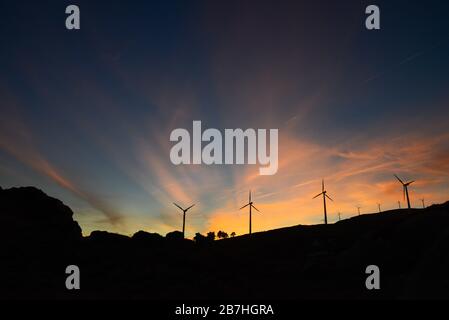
[0,0,449,237]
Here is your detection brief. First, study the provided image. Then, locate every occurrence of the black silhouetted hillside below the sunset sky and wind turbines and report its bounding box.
[0,187,449,299]
